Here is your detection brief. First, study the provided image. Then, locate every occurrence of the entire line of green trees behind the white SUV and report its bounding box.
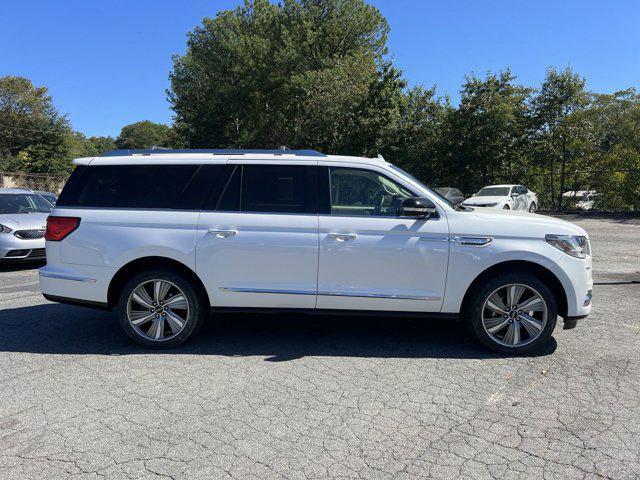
[0,0,640,210]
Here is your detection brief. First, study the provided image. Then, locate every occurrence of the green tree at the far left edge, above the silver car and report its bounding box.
[0,76,71,173]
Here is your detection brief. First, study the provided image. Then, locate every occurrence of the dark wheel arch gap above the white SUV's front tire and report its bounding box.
[461,260,567,317]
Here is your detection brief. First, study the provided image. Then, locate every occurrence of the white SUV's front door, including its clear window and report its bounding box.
[317,167,449,312]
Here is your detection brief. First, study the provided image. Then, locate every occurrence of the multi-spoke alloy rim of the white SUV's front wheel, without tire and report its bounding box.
[482,283,548,347]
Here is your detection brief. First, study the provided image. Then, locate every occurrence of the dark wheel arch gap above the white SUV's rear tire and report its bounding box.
[107,256,211,308]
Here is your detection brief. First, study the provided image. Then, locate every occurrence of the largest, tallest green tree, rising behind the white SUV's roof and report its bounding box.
[167,0,404,154]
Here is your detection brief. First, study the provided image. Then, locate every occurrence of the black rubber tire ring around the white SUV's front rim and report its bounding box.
[462,273,558,355]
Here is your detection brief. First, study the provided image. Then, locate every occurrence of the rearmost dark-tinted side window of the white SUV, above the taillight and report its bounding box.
[58,165,227,210]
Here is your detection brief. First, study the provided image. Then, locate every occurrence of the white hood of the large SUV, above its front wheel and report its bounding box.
[468,207,588,238]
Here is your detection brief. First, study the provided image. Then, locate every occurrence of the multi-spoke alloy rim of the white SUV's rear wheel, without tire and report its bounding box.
[127,279,190,342]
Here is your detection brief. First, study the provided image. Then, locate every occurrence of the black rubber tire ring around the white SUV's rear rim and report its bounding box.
[118,270,207,349]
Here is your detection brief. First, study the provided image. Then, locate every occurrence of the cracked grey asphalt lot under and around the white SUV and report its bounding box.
[0,217,640,480]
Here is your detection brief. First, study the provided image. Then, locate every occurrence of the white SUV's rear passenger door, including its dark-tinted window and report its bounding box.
[196,161,318,308]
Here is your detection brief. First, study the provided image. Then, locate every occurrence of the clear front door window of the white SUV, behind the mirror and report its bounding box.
[329,167,414,217]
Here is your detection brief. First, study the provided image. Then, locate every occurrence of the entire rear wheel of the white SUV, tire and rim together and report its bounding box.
[118,269,209,349]
